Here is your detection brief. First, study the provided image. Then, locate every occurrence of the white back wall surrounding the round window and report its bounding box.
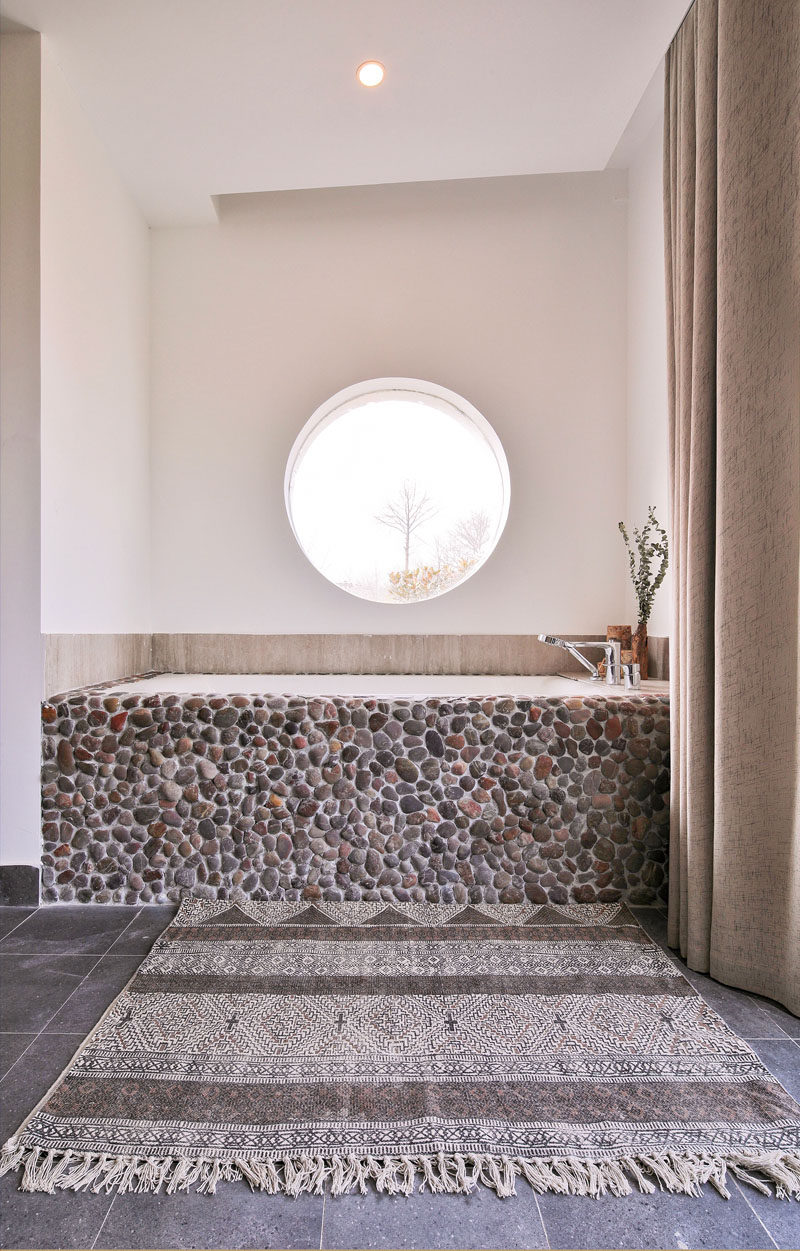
[151,171,626,633]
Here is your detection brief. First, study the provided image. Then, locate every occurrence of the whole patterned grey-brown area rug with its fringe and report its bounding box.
[3,899,800,1197]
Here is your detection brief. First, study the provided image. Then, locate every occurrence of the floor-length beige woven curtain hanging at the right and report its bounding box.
[665,0,800,1015]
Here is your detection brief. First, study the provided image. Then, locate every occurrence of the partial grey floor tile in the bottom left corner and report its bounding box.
[0,1173,111,1251]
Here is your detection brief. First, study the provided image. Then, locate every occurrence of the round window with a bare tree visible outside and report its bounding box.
[285,378,510,604]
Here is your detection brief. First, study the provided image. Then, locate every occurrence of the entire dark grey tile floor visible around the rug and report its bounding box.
[0,906,800,1251]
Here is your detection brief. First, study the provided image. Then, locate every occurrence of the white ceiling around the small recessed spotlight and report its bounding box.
[0,0,687,225]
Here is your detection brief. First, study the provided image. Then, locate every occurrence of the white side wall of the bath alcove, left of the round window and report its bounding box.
[41,49,150,633]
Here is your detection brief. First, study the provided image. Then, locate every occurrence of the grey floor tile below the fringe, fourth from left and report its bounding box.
[538,1186,770,1251]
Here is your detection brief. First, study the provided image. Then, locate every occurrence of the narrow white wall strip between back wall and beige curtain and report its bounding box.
[626,113,671,634]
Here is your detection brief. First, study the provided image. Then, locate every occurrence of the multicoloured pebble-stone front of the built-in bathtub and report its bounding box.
[41,691,670,903]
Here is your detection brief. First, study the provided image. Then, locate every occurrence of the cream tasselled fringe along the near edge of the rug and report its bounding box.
[0,1137,800,1200]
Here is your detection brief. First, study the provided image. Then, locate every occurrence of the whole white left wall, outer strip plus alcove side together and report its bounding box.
[0,48,150,864]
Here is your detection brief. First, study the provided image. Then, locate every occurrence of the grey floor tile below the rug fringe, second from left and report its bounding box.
[98,1182,323,1251]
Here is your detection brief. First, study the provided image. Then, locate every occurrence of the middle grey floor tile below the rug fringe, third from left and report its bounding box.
[322,1182,547,1251]
